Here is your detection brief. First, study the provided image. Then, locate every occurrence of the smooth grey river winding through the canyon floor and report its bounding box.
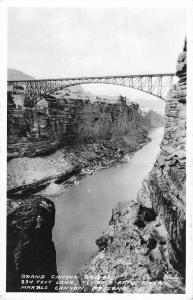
[53,128,163,286]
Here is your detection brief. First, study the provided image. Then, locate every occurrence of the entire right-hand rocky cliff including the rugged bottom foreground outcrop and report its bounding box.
[79,42,186,293]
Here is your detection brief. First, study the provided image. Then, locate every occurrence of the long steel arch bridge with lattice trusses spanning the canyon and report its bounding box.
[8,73,176,107]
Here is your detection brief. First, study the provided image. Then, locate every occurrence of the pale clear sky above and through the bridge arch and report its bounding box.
[8,5,186,105]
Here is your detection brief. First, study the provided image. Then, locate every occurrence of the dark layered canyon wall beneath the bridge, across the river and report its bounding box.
[8,98,152,158]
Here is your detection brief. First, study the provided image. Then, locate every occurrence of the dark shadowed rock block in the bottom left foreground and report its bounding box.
[6,196,57,292]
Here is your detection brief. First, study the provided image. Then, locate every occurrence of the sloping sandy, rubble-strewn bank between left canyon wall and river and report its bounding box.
[7,134,149,189]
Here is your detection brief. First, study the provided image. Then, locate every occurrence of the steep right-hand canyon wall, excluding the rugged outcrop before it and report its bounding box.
[138,46,186,275]
